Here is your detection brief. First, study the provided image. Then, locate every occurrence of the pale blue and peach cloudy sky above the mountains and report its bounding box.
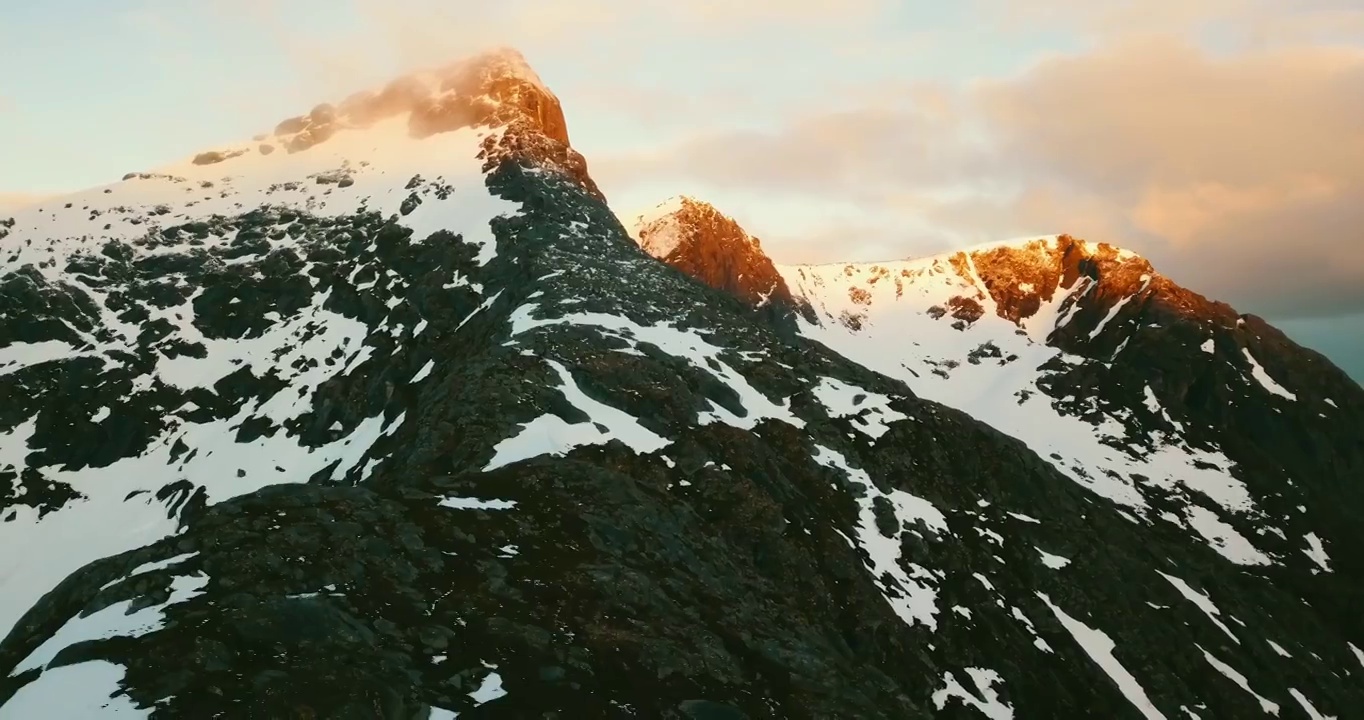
[0,0,1364,378]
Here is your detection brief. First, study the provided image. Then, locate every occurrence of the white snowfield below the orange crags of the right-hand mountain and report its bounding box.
[782,237,1260,565]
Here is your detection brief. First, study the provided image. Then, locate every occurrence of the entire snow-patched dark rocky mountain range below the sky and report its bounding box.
[0,50,1364,720]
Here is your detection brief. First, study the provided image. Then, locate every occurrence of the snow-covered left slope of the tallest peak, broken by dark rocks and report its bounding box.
[0,119,518,640]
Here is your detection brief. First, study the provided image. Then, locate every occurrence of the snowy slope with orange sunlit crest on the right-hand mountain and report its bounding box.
[779,236,1358,570]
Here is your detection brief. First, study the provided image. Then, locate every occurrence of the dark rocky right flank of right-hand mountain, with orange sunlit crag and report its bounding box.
[975,236,1364,597]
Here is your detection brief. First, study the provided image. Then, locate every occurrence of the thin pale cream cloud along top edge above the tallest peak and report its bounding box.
[195,0,893,95]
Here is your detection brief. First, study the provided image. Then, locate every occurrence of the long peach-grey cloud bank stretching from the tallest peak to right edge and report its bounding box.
[596,35,1364,316]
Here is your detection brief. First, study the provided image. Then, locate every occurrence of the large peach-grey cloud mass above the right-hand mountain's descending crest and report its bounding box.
[975,41,1364,315]
